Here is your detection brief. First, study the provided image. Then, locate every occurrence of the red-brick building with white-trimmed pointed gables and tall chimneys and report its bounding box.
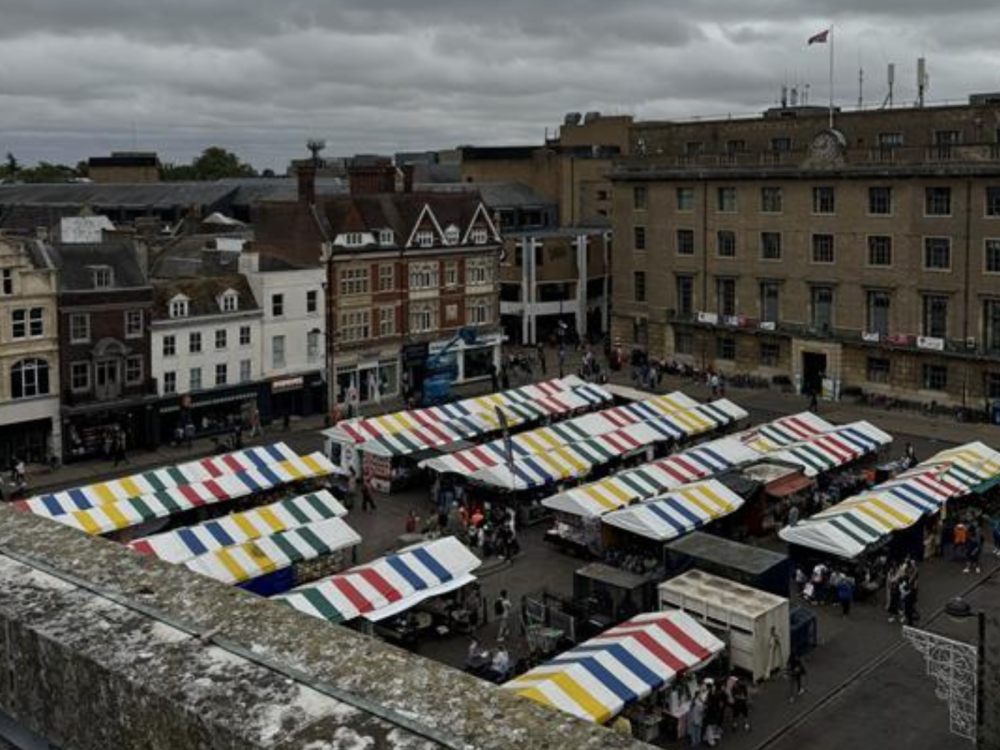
[255,162,502,412]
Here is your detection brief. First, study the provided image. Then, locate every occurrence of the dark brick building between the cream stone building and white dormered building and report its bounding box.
[51,243,156,461]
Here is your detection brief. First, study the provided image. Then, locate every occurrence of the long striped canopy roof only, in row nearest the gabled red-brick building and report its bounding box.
[335,376,611,450]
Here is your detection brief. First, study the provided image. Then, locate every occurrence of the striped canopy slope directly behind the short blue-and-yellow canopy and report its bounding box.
[542,437,760,518]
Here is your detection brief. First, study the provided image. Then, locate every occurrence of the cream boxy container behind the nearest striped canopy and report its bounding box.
[659,570,791,681]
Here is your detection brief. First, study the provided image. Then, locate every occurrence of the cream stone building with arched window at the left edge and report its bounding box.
[0,237,62,467]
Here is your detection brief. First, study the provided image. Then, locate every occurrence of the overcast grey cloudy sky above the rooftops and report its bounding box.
[0,0,1000,169]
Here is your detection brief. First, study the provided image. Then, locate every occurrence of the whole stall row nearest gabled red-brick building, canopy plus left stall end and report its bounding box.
[323,376,612,492]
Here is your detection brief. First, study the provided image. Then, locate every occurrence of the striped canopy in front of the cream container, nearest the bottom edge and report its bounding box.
[503,610,724,724]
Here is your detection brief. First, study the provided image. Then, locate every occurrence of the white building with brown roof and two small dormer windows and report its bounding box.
[151,273,262,442]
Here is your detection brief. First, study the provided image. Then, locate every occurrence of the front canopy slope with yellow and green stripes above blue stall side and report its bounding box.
[184,518,361,584]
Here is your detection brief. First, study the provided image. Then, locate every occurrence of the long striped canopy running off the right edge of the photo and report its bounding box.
[779,443,1000,559]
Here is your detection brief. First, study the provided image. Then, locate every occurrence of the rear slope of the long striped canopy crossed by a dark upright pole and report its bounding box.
[420,392,698,474]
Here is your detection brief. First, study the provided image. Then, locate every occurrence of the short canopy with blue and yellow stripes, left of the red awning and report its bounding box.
[601,479,743,542]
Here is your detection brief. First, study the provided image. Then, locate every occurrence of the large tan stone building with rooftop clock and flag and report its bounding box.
[613,99,1000,408]
